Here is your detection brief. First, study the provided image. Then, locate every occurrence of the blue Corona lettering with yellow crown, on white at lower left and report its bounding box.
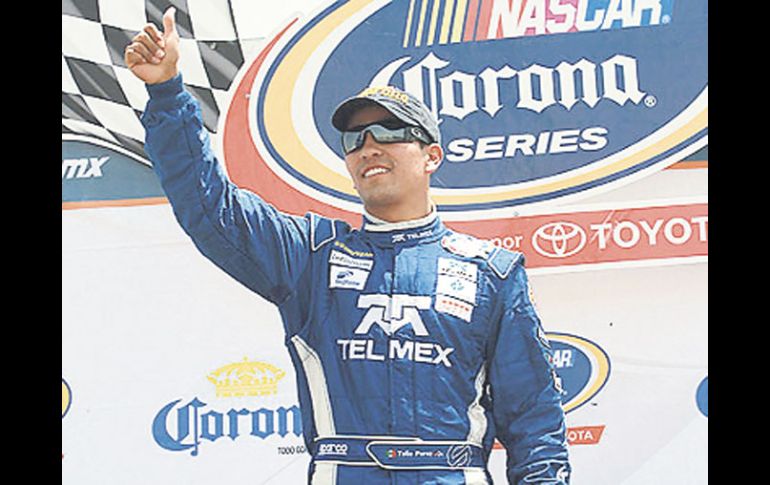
[152,358,302,456]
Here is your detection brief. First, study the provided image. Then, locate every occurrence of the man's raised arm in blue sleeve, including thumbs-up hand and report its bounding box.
[125,8,317,310]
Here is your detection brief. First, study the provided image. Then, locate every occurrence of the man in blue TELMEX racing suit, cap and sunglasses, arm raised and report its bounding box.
[125,9,570,485]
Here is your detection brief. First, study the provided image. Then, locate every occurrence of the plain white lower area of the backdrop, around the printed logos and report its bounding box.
[62,169,708,485]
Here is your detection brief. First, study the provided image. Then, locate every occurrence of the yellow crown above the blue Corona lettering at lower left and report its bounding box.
[207,357,286,397]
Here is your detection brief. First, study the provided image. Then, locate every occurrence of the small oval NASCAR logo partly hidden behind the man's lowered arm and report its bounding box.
[546,332,610,413]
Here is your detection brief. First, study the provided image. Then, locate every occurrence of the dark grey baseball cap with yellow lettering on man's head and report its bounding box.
[332,86,441,143]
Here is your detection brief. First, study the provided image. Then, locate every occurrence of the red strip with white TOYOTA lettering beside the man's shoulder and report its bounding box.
[447,203,708,268]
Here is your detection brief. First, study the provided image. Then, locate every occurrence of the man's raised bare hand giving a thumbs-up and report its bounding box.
[123,7,179,84]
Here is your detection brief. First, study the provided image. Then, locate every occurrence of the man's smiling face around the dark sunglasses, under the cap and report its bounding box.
[345,106,441,216]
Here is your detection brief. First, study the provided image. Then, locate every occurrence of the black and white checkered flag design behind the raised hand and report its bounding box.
[62,0,249,159]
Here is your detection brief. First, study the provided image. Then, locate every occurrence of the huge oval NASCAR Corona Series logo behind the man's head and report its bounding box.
[223,0,708,214]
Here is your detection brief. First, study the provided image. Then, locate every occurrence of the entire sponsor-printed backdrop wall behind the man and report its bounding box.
[62,0,708,485]
